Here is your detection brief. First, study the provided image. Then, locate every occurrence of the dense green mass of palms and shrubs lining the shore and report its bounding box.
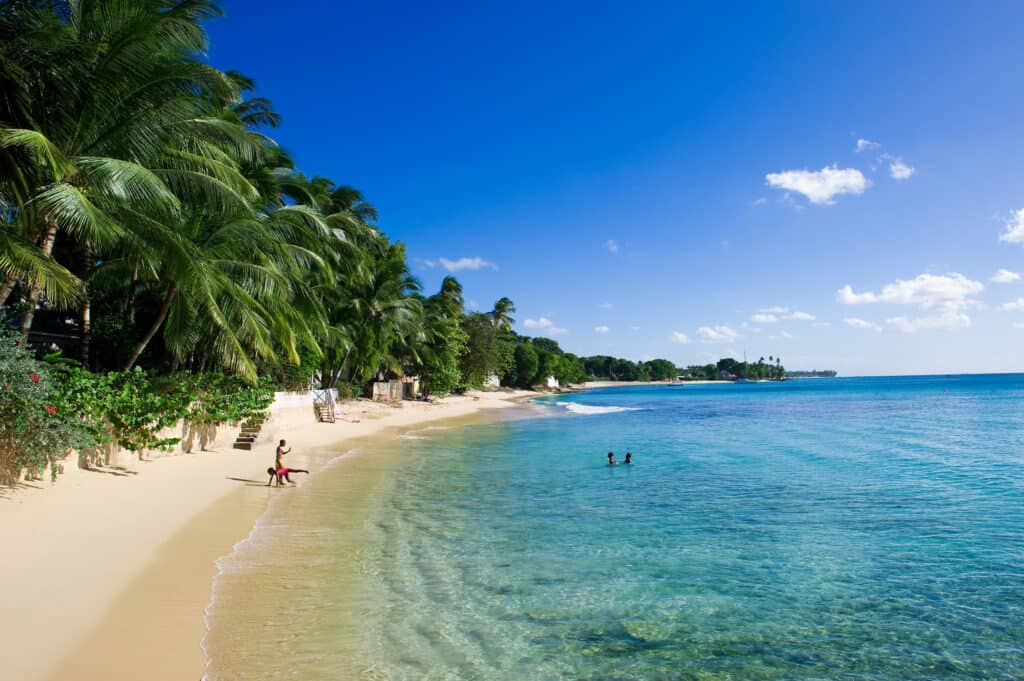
[0,0,781,475]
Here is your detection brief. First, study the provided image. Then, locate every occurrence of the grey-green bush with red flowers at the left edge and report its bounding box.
[0,335,96,484]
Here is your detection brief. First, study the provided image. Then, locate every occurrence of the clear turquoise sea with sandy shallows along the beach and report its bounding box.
[201,376,1024,680]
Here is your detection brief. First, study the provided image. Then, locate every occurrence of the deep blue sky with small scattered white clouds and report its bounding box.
[210,0,1024,375]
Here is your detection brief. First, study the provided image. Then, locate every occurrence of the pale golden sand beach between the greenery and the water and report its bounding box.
[0,391,537,681]
